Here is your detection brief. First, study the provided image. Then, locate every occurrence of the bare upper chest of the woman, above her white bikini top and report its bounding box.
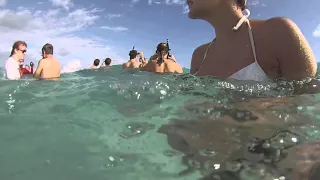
[197,36,280,78]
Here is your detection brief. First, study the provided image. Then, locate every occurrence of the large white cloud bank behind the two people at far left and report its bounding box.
[0,5,125,71]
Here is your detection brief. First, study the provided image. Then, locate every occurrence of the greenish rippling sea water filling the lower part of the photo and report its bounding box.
[0,66,320,180]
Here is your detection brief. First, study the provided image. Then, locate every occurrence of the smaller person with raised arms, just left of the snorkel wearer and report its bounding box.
[122,50,147,69]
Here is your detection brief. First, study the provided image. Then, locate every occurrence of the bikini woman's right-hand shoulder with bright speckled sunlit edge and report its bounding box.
[265,17,317,80]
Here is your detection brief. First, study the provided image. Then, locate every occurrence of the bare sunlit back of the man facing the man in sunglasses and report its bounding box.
[41,58,61,79]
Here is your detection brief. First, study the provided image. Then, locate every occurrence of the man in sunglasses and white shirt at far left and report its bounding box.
[5,41,27,80]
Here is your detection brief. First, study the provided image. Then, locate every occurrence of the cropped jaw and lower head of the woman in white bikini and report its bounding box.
[187,0,247,19]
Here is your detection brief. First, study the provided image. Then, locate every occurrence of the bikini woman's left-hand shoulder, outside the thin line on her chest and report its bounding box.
[190,42,214,74]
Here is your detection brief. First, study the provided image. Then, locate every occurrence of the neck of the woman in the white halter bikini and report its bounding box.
[206,6,243,39]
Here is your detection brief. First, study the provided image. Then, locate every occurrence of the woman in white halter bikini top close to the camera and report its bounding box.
[187,0,317,81]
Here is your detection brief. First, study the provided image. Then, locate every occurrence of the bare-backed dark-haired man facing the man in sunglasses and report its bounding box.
[33,43,61,80]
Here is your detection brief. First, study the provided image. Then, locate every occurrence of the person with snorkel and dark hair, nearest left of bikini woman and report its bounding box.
[140,43,183,73]
